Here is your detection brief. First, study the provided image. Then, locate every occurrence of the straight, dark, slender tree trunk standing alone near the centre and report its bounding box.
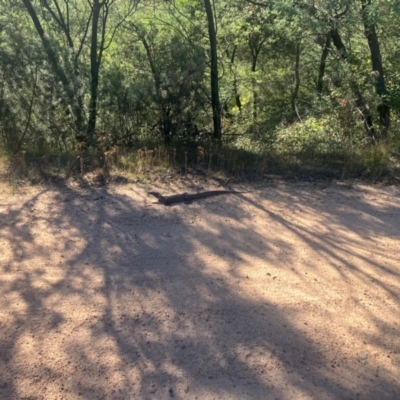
[204,0,222,143]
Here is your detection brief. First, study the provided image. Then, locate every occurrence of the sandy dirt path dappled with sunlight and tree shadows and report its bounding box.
[0,183,400,400]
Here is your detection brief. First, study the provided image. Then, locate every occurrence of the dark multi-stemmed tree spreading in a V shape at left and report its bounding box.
[22,0,137,145]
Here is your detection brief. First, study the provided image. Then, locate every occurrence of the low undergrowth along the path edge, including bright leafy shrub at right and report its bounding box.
[0,118,400,189]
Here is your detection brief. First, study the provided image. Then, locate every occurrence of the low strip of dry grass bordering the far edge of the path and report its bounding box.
[0,138,400,191]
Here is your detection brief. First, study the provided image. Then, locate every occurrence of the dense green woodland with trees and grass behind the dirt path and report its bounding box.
[0,0,400,181]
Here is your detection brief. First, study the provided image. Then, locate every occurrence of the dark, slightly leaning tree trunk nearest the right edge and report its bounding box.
[361,0,390,136]
